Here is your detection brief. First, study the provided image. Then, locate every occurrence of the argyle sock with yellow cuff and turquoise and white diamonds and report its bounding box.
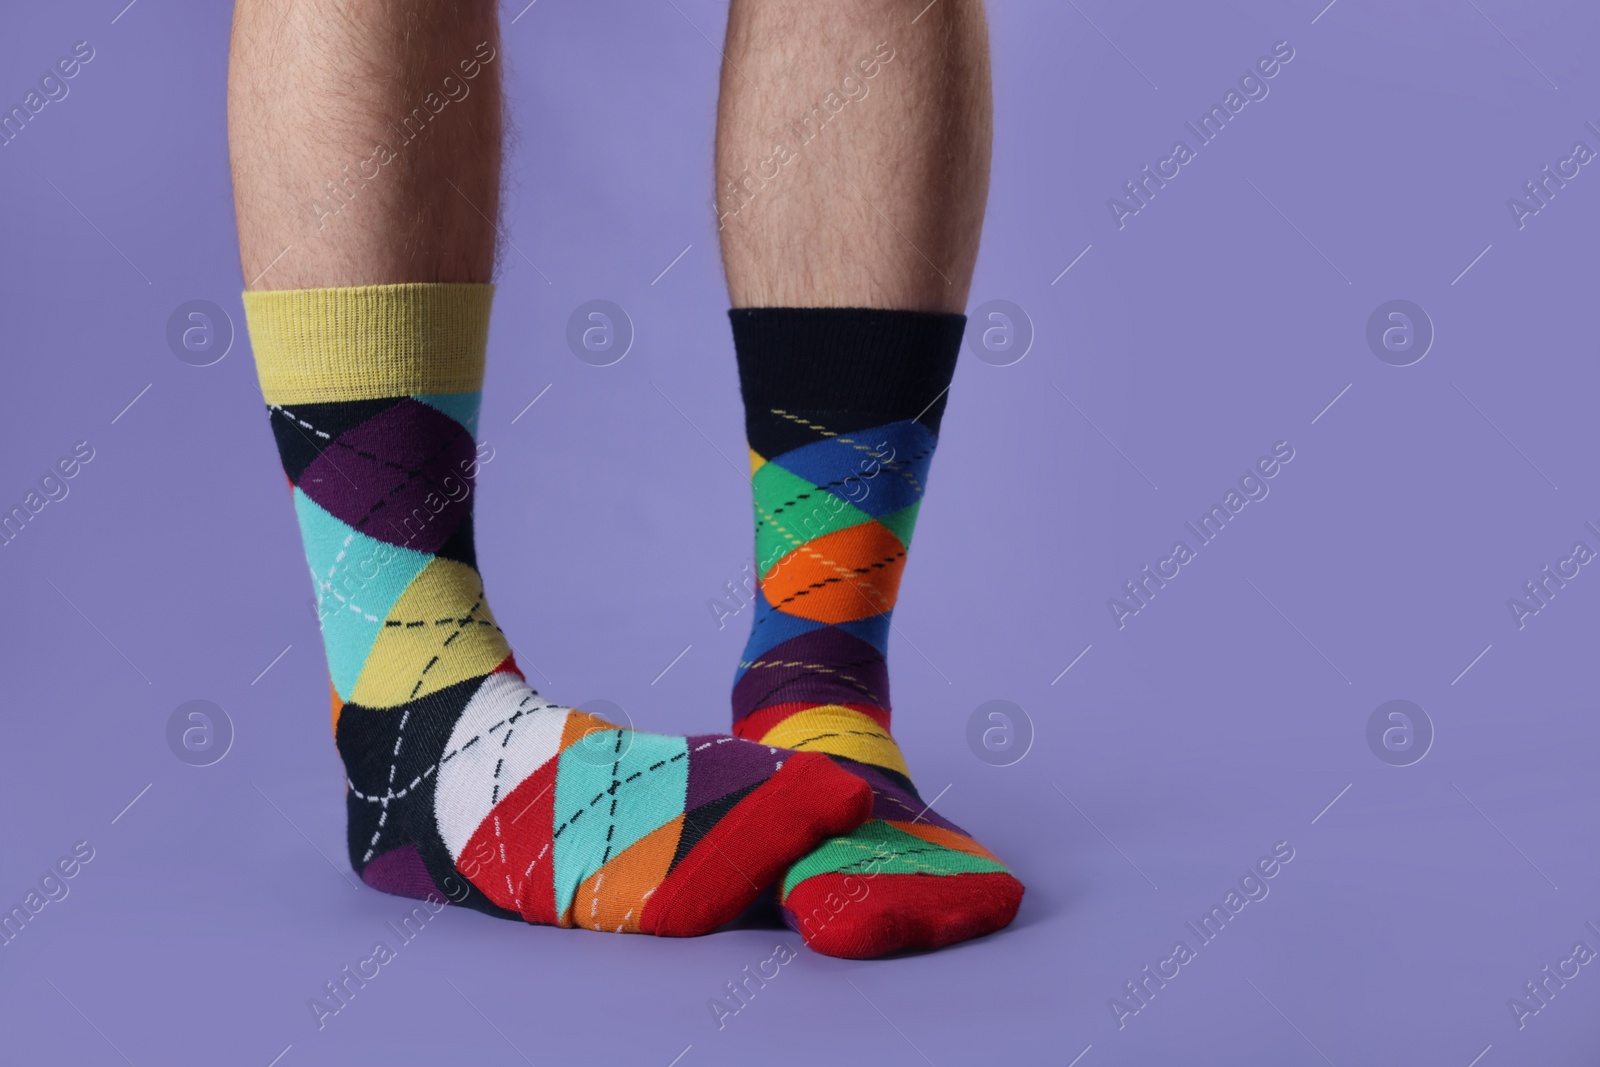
[245,285,870,936]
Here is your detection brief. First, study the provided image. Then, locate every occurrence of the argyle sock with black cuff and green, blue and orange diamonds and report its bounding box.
[731,309,1022,958]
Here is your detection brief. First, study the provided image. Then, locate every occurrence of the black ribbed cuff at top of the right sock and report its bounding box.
[728,307,966,440]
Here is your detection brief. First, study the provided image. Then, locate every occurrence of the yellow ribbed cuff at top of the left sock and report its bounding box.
[245,282,494,405]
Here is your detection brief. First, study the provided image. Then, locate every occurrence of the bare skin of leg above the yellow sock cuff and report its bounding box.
[227,0,502,290]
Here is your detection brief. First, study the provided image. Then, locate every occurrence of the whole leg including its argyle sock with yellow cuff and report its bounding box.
[229,0,872,934]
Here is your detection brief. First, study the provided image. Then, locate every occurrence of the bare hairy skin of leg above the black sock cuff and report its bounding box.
[717,0,992,312]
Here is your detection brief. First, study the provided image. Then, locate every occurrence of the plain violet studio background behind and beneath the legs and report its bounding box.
[0,0,1600,1067]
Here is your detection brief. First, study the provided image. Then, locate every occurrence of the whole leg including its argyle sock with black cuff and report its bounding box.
[717,0,1022,957]
